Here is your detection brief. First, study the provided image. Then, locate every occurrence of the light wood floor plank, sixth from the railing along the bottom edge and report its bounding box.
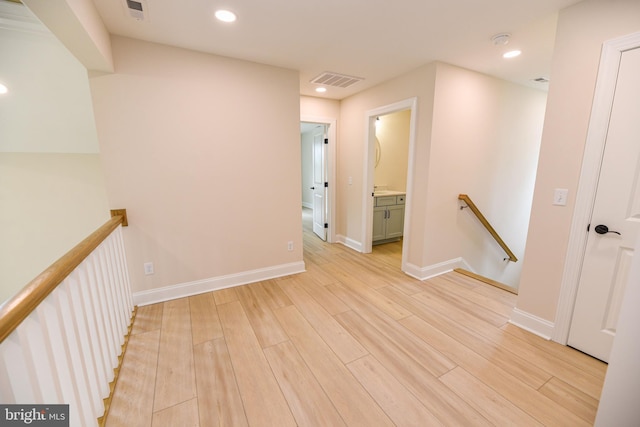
[276,306,394,427]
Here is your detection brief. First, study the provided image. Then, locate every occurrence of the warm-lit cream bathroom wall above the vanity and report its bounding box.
[374,110,411,191]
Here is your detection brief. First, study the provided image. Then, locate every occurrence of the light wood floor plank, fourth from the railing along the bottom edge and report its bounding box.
[218,301,296,427]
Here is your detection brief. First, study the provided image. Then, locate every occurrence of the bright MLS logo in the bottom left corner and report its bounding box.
[0,405,69,427]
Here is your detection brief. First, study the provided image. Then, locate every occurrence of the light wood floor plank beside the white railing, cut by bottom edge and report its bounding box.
[106,329,160,427]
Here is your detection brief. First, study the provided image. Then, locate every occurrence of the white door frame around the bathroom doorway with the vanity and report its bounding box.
[362,97,418,271]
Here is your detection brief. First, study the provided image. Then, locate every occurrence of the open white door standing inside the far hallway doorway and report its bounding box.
[311,127,327,241]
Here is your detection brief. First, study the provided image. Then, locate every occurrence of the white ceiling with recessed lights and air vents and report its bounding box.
[94,0,578,99]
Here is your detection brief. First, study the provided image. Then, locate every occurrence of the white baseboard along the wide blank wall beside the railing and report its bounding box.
[133,261,306,306]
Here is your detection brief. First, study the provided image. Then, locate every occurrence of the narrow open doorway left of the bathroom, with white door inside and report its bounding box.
[300,117,335,243]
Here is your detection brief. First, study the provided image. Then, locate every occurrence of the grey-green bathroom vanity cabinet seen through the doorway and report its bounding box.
[372,194,406,244]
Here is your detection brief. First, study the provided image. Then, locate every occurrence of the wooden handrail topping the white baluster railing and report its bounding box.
[0,215,125,342]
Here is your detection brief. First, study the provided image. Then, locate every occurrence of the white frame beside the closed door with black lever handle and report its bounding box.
[551,33,640,345]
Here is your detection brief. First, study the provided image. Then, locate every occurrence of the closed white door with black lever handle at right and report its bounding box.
[568,48,640,361]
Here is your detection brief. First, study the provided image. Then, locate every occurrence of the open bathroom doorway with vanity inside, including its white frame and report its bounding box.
[362,98,417,271]
